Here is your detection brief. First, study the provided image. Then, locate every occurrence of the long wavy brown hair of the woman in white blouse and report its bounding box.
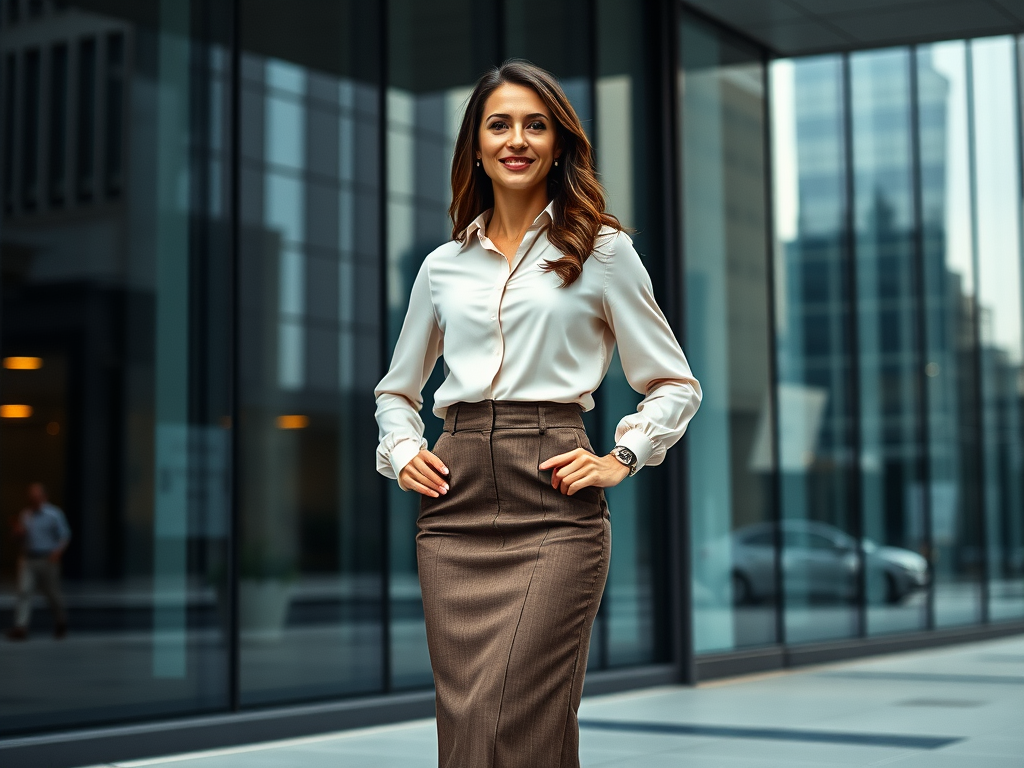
[449,58,624,288]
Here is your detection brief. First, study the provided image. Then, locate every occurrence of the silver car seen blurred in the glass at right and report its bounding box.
[716,520,929,605]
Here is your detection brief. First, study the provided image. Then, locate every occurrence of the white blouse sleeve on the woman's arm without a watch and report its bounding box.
[374,256,444,493]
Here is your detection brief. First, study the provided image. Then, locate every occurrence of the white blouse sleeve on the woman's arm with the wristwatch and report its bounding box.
[604,232,700,469]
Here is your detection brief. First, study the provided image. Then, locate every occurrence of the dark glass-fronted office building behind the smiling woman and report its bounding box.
[0,0,1024,766]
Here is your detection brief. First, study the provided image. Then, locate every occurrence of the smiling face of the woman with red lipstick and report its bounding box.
[476,83,561,191]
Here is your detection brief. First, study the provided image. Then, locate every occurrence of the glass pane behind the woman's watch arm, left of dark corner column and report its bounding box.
[598,0,678,667]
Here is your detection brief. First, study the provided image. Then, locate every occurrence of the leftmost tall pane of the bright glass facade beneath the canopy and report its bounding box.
[771,56,858,643]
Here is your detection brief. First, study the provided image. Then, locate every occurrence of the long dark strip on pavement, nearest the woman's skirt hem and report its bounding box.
[580,720,964,750]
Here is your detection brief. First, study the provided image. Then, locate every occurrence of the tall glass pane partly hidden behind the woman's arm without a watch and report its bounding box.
[385,0,499,688]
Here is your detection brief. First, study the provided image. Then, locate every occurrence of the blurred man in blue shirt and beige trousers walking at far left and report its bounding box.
[7,482,71,640]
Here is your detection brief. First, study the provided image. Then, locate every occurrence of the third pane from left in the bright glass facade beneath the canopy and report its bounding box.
[916,41,981,627]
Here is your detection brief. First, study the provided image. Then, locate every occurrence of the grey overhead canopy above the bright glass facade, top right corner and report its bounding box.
[687,0,1024,56]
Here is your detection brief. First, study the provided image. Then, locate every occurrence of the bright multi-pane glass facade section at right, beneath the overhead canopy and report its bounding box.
[770,37,1024,643]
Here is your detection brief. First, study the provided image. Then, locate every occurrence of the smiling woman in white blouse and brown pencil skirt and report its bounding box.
[375,60,700,768]
